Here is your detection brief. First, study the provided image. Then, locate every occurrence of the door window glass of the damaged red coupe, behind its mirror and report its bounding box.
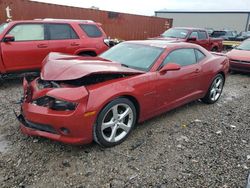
[163,48,196,66]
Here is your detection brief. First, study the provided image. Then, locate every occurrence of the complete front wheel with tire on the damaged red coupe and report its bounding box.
[94,98,137,147]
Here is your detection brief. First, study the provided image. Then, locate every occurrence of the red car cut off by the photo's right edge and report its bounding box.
[227,39,250,72]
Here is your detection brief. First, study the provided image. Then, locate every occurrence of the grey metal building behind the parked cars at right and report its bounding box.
[155,10,250,32]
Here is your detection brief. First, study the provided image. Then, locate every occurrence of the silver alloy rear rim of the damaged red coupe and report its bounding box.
[210,76,224,101]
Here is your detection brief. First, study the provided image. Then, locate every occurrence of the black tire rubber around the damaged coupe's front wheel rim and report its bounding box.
[94,98,137,147]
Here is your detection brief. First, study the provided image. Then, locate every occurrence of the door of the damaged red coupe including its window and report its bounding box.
[157,48,201,110]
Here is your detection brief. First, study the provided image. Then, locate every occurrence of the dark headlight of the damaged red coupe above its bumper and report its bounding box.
[32,96,77,111]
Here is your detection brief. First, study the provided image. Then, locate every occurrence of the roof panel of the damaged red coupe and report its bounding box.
[125,40,199,48]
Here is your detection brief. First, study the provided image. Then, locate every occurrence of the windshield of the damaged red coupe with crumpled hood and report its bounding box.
[100,43,164,71]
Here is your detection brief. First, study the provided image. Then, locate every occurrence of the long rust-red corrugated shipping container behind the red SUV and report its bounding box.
[0,0,172,40]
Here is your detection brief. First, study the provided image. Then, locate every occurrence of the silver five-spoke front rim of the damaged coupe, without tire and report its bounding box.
[101,103,134,142]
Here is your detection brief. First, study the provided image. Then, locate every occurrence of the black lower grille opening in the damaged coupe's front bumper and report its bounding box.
[17,115,57,134]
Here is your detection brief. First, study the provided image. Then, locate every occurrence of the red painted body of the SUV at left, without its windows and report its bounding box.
[0,20,108,74]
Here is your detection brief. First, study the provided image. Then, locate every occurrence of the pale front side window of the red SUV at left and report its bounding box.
[8,24,44,41]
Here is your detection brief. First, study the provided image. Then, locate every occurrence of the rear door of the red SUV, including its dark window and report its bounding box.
[46,23,81,54]
